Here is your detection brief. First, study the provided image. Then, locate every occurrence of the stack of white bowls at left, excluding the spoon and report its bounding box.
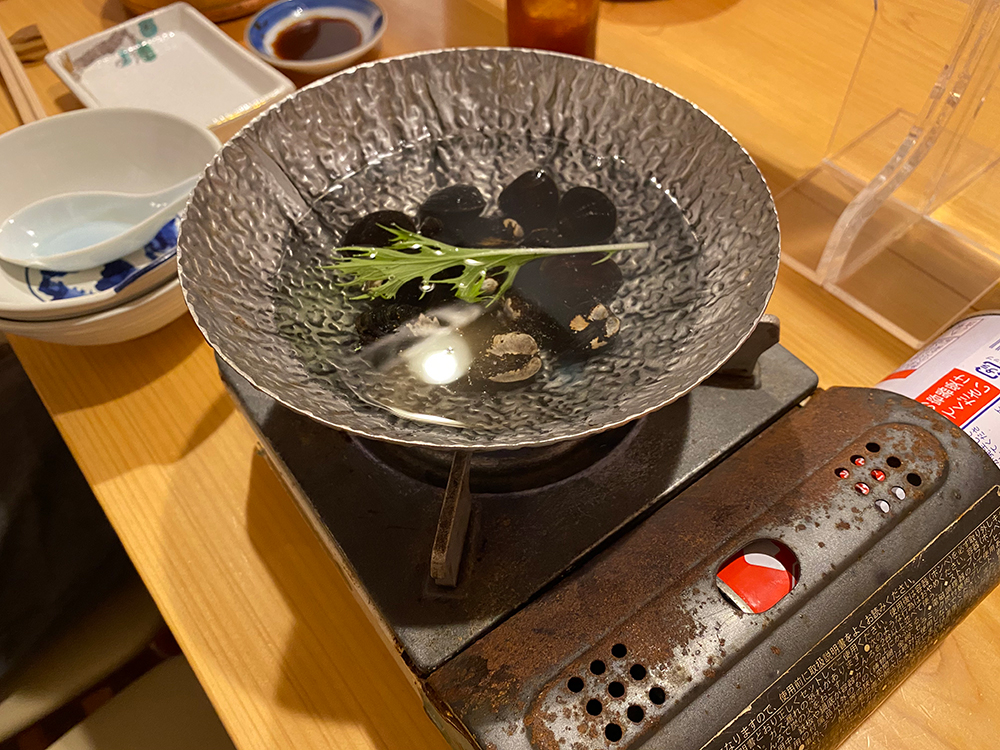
[0,109,220,345]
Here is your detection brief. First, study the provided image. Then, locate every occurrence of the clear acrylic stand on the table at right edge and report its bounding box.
[776,0,1000,347]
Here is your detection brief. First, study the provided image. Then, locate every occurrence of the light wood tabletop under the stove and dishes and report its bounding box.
[0,0,1000,750]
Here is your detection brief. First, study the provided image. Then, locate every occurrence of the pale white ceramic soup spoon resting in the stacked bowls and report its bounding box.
[0,177,198,271]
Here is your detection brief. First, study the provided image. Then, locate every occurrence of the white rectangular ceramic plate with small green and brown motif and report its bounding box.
[45,3,295,140]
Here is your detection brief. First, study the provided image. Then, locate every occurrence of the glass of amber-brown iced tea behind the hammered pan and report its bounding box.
[507,0,599,58]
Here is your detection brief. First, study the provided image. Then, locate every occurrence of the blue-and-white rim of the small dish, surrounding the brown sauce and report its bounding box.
[243,0,385,76]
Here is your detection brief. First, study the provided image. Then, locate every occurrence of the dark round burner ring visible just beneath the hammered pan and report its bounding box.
[358,421,639,493]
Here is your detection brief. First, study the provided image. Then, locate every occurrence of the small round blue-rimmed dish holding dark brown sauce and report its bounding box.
[244,0,385,75]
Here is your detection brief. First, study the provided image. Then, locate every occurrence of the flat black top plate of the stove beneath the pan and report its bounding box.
[213,326,820,672]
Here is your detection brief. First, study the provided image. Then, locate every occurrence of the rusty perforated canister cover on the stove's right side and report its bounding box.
[426,388,1000,750]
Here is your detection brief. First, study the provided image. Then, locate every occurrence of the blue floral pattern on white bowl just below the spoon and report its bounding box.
[24,218,180,302]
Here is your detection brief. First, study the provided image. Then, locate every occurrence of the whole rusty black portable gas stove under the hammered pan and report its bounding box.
[220,319,1000,750]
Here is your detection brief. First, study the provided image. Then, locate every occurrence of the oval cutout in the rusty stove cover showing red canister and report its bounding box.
[716,539,799,614]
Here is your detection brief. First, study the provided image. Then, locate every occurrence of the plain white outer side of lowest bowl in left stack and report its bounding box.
[0,278,187,346]
